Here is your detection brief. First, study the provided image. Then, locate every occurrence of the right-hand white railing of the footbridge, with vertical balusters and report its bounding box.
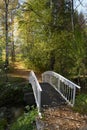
[42,71,80,106]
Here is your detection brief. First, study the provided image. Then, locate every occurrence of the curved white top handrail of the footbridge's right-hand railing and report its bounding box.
[42,71,81,89]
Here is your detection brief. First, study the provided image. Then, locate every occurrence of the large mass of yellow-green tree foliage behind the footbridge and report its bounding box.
[19,0,87,81]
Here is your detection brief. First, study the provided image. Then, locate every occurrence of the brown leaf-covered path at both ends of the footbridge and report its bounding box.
[8,62,87,130]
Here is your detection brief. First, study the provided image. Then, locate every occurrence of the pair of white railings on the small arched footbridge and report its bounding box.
[29,71,80,114]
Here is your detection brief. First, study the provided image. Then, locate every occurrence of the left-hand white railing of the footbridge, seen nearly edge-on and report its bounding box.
[29,71,42,115]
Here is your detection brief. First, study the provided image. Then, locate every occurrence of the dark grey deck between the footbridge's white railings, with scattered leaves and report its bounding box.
[40,83,65,107]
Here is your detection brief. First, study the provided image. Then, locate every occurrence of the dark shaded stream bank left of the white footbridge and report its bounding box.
[0,77,36,130]
